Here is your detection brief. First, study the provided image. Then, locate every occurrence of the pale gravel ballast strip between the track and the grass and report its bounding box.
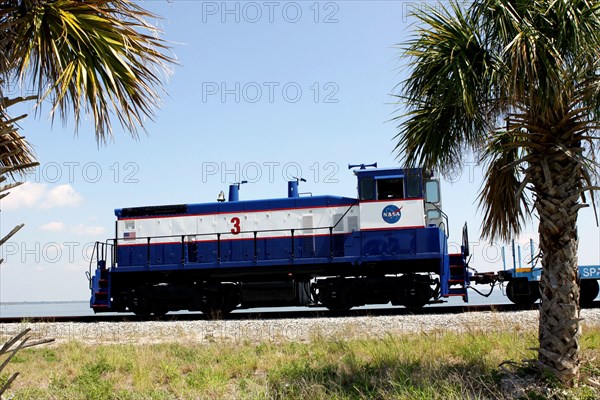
[0,309,600,344]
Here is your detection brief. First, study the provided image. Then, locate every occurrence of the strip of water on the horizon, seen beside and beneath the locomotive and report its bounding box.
[0,286,510,318]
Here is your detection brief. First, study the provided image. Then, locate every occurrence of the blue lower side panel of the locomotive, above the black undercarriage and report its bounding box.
[116,228,448,282]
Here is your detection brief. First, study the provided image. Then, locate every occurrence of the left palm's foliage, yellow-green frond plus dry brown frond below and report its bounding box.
[0,0,175,244]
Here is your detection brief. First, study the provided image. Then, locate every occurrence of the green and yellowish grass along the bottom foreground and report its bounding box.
[0,328,600,400]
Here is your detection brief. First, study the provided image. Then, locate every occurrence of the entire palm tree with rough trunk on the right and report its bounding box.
[396,0,600,385]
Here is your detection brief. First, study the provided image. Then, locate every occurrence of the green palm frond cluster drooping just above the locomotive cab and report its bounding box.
[396,3,496,170]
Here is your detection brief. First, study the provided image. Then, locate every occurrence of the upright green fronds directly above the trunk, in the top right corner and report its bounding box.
[470,0,600,117]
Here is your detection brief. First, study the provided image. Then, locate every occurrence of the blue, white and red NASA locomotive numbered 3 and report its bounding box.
[89,165,470,315]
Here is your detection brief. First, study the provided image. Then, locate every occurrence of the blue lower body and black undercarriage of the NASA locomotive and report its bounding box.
[92,227,462,315]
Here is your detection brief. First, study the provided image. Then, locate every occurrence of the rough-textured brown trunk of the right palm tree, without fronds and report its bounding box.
[528,152,581,386]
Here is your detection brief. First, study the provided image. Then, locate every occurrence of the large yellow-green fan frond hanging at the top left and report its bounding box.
[5,0,174,143]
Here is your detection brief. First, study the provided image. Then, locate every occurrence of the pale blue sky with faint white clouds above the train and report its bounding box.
[0,0,600,302]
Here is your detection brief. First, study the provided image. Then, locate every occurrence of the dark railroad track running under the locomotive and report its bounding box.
[0,301,600,324]
